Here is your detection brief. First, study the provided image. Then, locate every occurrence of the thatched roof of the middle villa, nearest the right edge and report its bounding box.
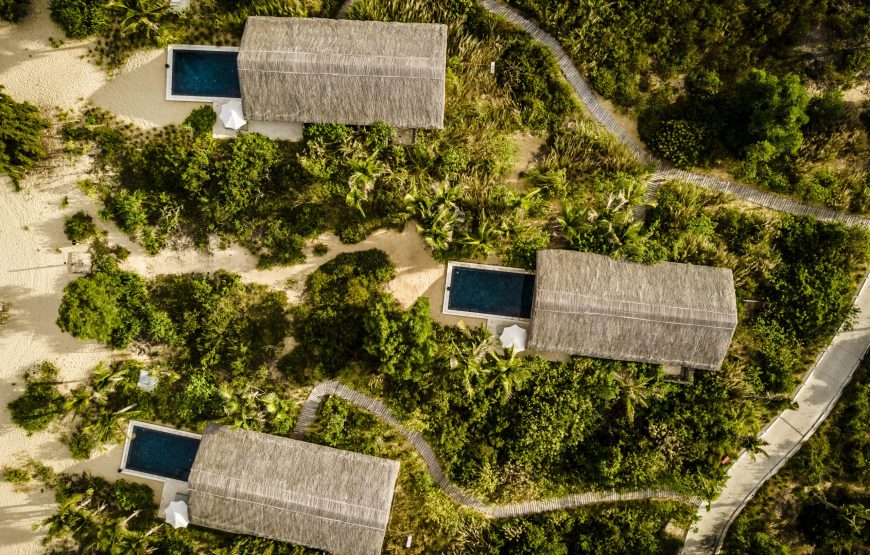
[529,250,737,370]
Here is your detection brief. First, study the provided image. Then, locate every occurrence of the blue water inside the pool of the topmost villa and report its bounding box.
[172,49,242,98]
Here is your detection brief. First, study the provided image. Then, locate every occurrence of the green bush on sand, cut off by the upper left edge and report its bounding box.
[0,87,48,183]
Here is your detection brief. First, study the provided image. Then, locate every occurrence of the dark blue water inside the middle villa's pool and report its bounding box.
[447,267,535,318]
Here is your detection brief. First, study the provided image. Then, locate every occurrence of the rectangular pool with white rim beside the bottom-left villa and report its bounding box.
[121,421,200,482]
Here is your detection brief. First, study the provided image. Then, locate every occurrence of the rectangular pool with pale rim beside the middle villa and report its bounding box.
[444,262,535,321]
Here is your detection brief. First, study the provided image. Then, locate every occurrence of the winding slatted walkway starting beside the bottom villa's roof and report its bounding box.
[292,381,700,518]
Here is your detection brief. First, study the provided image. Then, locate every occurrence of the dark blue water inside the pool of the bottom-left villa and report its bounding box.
[126,426,199,481]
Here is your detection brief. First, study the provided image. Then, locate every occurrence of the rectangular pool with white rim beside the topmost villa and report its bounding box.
[166,44,242,102]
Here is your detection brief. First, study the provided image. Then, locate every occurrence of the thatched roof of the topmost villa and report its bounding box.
[238,17,447,129]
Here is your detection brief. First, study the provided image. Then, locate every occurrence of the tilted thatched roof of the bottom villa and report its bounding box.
[188,423,399,555]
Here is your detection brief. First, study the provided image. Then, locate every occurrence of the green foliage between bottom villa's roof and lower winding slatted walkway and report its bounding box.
[307,397,692,555]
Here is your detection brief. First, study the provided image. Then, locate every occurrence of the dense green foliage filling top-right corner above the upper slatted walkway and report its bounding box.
[511,0,870,213]
